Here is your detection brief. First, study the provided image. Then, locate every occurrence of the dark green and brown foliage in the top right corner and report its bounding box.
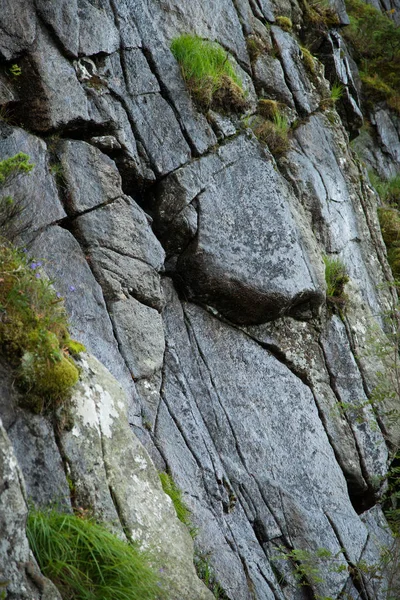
[343,0,400,110]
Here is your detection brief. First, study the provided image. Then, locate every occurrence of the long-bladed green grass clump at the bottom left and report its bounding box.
[27,510,165,600]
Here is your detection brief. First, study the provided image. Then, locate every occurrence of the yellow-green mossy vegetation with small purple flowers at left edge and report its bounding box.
[0,154,84,412]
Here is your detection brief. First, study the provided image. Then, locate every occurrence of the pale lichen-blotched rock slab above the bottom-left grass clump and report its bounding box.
[63,355,213,600]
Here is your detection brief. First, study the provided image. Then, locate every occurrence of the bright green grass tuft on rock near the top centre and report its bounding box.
[171,34,247,113]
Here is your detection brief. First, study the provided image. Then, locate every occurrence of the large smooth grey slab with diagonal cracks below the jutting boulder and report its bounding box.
[155,282,382,598]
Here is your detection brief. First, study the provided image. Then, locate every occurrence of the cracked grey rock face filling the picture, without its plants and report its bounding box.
[0,0,400,600]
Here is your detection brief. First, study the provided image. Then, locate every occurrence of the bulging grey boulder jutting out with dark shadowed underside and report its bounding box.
[159,137,322,323]
